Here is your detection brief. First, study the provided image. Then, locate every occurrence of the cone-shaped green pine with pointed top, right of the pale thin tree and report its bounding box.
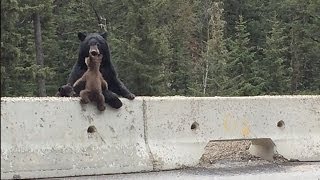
[226,16,264,96]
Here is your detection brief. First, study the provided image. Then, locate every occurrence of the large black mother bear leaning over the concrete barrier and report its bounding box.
[57,32,135,109]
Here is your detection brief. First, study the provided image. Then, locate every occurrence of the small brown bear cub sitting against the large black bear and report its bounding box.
[73,53,108,111]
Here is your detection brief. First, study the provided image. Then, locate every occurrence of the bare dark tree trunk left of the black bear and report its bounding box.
[33,12,46,97]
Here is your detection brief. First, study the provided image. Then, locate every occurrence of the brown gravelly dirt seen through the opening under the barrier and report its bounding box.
[199,140,287,167]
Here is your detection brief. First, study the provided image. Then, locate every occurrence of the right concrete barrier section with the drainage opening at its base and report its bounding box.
[144,96,320,169]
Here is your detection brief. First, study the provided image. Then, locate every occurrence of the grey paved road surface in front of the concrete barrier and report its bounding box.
[49,163,320,180]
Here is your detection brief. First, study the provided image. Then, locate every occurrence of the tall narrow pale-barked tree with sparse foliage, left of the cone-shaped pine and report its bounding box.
[203,2,228,96]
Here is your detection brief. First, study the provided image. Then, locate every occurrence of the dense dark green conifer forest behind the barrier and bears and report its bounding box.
[1,0,320,96]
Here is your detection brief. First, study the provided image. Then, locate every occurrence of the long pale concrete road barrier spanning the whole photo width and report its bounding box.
[1,96,320,179]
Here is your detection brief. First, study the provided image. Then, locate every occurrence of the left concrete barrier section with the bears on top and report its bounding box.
[1,98,152,178]
